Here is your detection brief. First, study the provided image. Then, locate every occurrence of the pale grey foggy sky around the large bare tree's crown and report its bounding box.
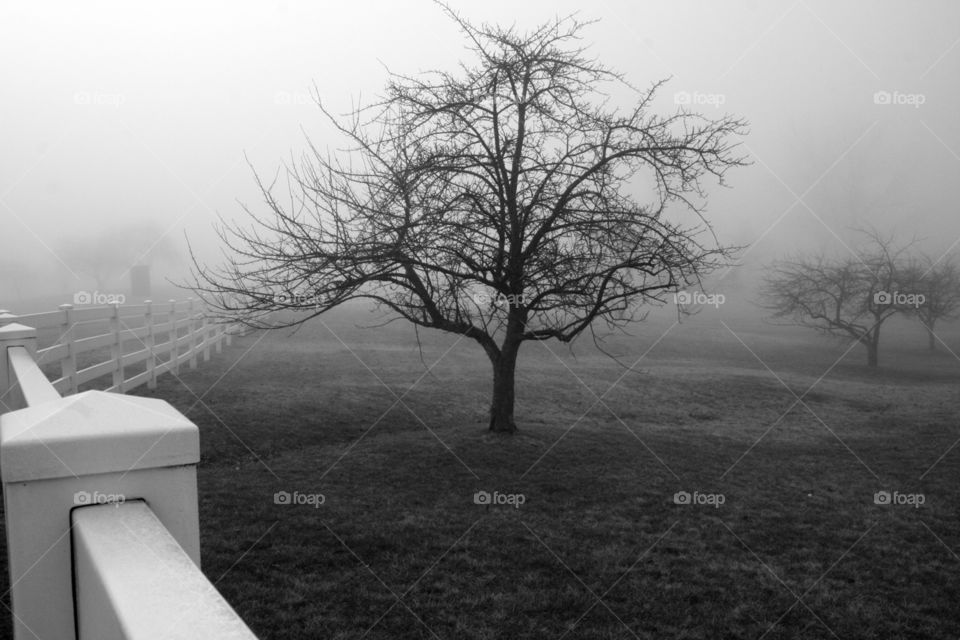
[0,0,960,307]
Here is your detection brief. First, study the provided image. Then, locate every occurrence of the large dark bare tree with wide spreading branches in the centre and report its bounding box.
[193,6,745,432]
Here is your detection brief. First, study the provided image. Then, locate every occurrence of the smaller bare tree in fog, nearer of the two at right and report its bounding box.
[760,230,917,367]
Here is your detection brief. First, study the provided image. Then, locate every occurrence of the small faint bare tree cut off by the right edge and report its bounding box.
[907,254,960,351]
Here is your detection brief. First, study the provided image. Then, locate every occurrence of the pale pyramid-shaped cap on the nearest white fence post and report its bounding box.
[0,390,200,483]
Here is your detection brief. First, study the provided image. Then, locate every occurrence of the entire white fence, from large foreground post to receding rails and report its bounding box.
[0,302,256,640]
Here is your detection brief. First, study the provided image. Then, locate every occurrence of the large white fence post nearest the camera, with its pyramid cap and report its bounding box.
[0,388,200,640]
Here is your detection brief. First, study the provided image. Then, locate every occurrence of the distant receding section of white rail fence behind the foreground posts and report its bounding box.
[0,300,243,408]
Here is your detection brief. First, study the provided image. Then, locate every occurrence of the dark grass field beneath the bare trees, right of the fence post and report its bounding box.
[0,304,960,639]
